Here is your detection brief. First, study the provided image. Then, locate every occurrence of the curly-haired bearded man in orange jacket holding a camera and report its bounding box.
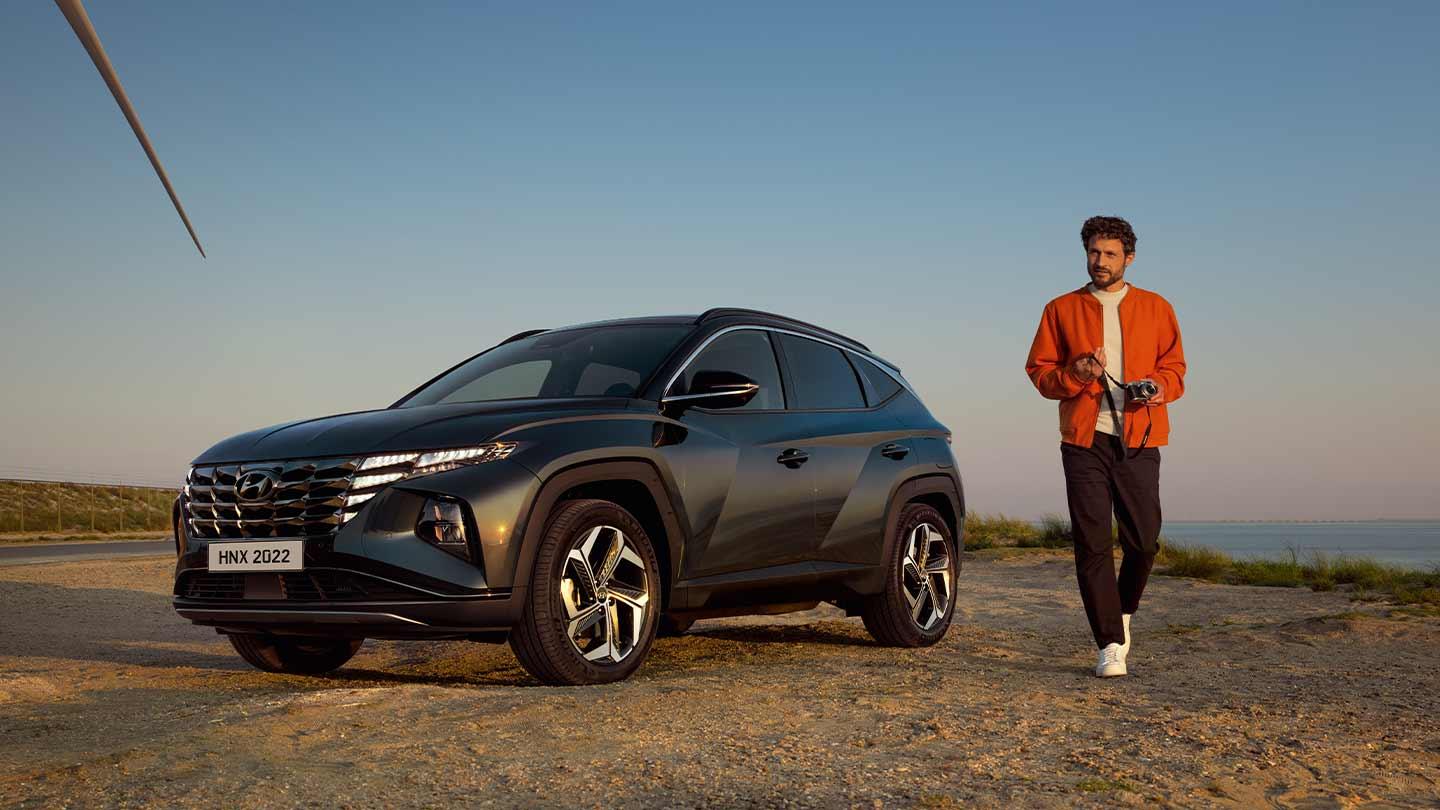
[1025,216,1185,677]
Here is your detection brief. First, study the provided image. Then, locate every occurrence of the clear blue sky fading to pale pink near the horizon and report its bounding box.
[0,0,1440,520]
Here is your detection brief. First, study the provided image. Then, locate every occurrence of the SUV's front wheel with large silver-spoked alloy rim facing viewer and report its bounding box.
[510,499,661,686]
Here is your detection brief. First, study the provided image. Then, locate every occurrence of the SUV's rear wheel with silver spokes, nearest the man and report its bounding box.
[861,503,959,647]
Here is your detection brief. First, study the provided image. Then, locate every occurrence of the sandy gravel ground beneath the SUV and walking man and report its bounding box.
[0,552,1440,807]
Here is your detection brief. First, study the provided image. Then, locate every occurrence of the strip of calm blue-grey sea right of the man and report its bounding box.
[1161,520,1440,571]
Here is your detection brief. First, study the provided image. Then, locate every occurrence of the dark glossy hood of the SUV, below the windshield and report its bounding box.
[192,396,629,464]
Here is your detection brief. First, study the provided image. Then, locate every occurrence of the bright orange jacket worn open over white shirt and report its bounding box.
[1025,284,1185,447]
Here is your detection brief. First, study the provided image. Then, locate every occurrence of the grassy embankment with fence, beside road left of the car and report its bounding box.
[0,479,179,535]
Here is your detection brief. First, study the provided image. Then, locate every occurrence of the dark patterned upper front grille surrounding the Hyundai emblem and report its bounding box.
[181,458,360,539]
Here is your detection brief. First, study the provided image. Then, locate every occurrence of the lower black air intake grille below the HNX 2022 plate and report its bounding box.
[176,569,431,602]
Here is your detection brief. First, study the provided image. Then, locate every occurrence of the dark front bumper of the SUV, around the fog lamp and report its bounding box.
[173,461,537,640]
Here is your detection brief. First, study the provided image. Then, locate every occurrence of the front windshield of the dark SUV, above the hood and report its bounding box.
[396,326,694,408]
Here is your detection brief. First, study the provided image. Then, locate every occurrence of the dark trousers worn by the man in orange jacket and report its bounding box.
[1060,432,1161,647]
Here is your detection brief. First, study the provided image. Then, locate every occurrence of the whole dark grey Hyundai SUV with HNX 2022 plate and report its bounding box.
[174,308,965,685]
